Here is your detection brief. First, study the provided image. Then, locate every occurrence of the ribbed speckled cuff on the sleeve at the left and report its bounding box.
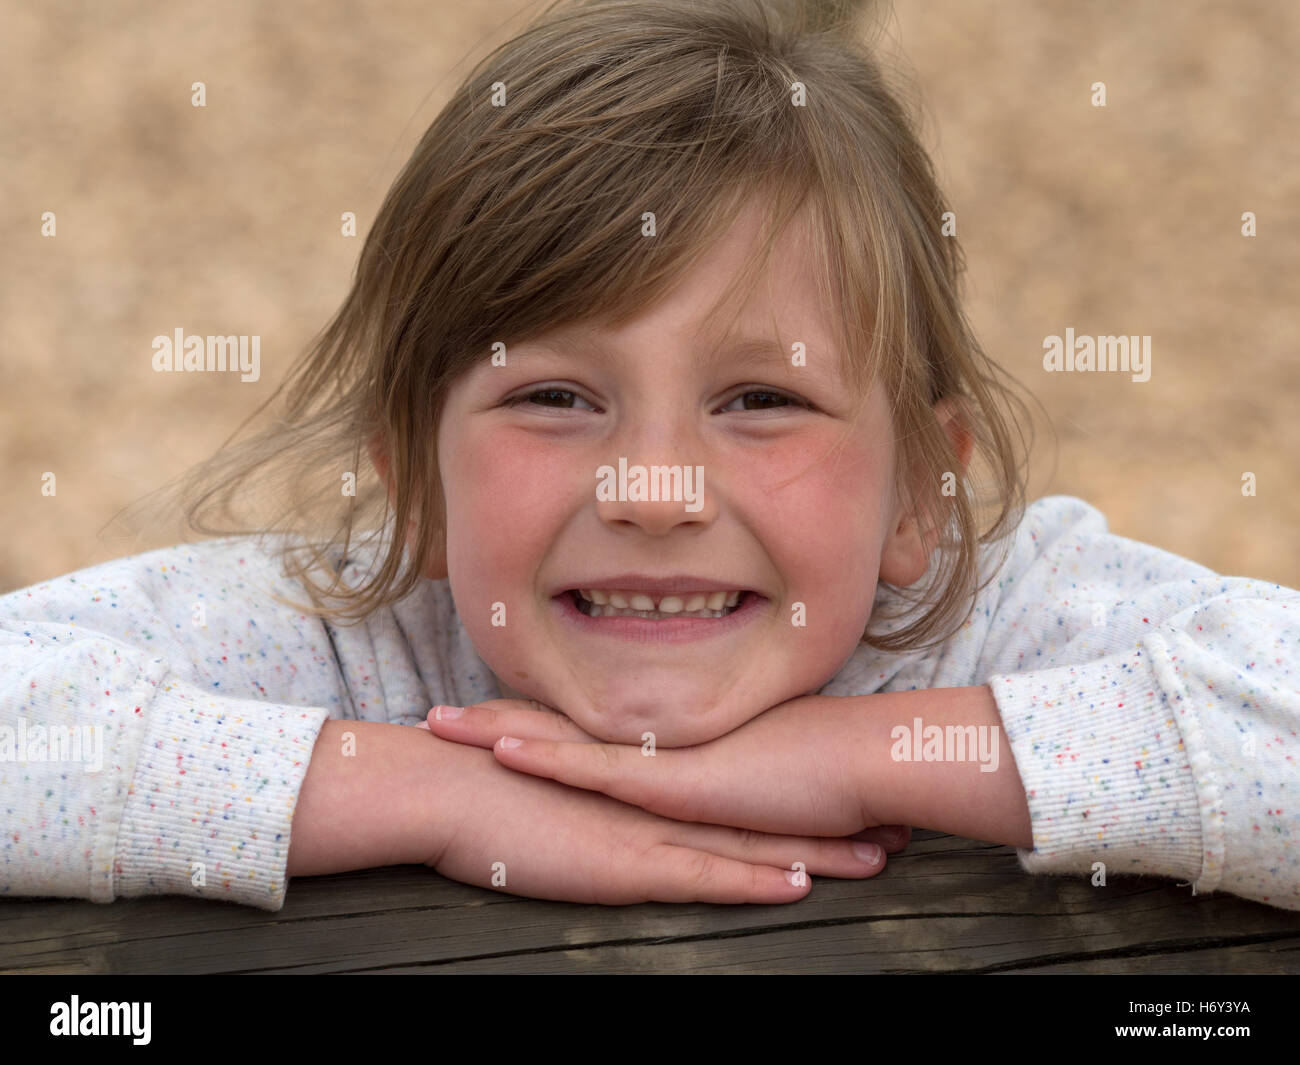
[113,672,329,910]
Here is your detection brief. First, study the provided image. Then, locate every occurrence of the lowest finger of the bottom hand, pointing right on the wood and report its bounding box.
[634,843,813,904]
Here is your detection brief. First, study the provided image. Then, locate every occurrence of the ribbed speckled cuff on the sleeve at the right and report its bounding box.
[988,650,1213,889]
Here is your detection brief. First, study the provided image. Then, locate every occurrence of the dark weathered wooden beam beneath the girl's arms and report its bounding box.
[0,832,1300,973]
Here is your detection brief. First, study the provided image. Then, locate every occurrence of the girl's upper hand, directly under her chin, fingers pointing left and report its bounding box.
[428,696,910,847]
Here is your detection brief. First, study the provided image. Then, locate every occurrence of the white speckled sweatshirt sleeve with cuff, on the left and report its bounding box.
[0,555,329,910]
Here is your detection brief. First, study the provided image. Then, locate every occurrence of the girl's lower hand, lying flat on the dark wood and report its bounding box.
[423,723,904,905]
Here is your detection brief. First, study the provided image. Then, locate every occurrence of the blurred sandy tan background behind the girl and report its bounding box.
[0,0,1300,592]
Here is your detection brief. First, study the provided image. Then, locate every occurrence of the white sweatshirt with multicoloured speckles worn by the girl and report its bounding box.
[0,495,1300,910]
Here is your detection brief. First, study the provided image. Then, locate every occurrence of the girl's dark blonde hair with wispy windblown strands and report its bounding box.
[119,0,1026,651]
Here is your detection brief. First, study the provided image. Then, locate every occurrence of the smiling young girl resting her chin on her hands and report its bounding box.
[0,0,1300,910]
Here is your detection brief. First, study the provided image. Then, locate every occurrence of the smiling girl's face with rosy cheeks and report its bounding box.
[438,201,926,746]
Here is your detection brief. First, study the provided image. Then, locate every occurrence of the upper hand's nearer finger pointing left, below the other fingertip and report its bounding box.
[493,733,691,823]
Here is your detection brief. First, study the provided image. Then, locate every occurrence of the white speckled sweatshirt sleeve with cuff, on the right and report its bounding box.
[980,497,1300,909]
